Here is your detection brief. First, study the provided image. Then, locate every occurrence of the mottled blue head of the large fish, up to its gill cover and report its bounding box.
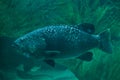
[13,35,46,57]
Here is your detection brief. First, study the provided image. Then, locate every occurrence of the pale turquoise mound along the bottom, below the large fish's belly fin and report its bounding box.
[17,61,79,80]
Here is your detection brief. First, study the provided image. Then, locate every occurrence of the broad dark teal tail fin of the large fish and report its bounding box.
[99,29,113,53]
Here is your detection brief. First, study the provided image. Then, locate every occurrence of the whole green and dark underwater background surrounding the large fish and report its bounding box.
[0,0,120,80]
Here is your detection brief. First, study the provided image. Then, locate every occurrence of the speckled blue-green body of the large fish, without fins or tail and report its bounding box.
[15,25,99,59]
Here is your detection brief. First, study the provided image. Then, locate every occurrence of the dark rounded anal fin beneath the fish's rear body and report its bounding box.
[78,52,93,61]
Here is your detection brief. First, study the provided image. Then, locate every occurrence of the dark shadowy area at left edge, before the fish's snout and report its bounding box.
[0,37,25,70]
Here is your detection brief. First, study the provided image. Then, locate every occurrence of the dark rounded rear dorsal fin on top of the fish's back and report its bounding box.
[75,23,95,34]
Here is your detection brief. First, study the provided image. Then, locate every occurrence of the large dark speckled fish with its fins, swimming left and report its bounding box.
[13,24,113,66]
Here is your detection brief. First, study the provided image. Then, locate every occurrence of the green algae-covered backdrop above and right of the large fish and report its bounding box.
[0,0,120,80]
